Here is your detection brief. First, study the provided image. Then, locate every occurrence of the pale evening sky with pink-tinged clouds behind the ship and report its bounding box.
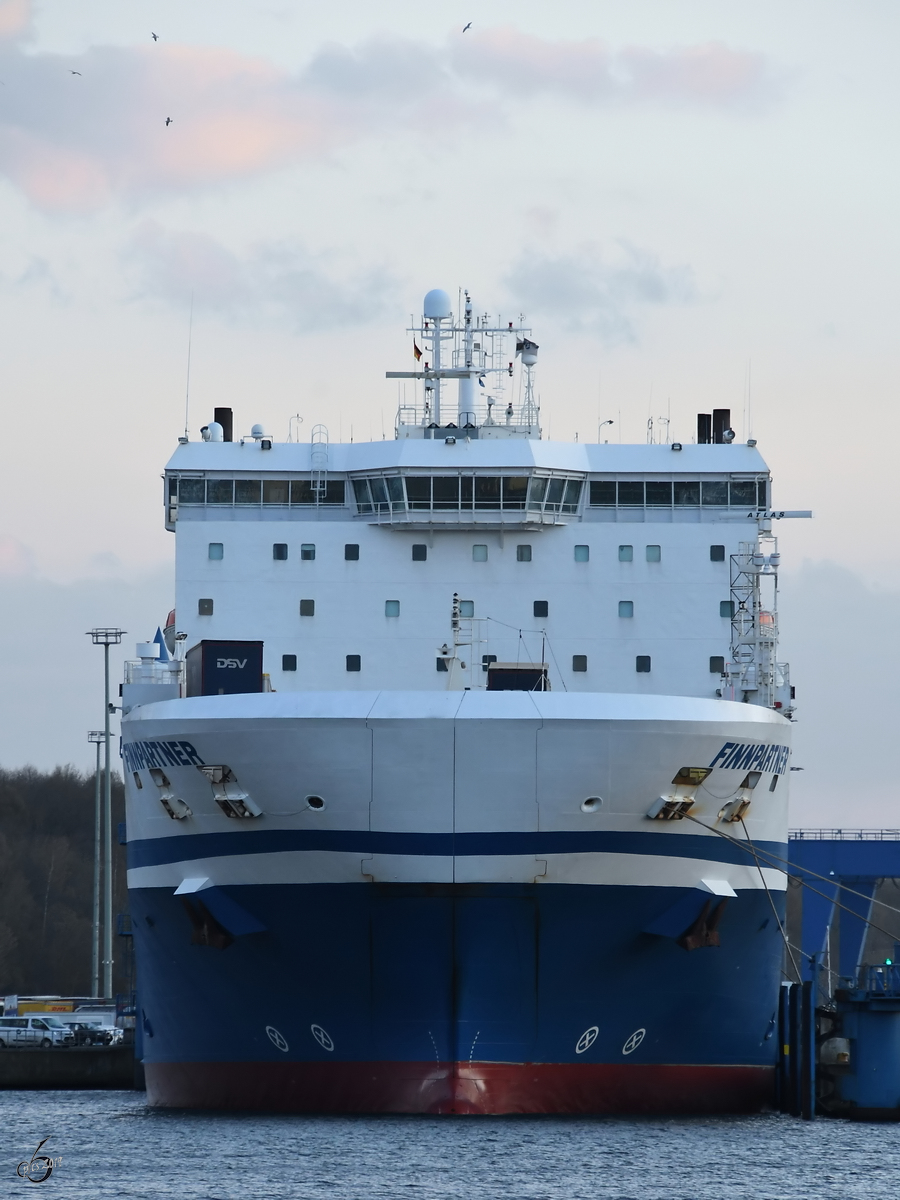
[0,0,900,826]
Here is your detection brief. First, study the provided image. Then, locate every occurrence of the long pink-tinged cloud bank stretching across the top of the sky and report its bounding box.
[0,28,764,211]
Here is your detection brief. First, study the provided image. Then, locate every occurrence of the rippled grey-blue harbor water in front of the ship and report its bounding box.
[7,1091,900,1200]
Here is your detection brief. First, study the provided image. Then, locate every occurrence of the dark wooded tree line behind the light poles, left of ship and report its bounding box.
[0,767,128,996]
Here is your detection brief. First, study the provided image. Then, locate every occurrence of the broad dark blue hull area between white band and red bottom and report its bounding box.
[131,883,784,1069]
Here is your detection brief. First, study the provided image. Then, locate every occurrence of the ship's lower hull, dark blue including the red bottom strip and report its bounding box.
[131,883,784,1111]
